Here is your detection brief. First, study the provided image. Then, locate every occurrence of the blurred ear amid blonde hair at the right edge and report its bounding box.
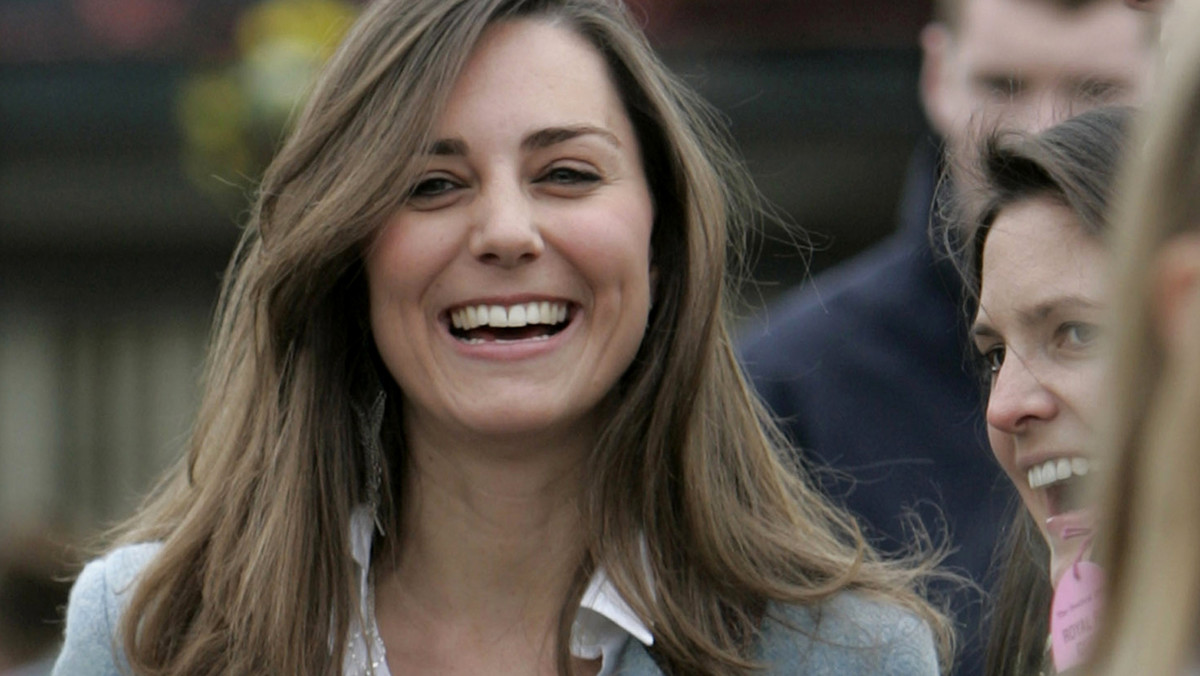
[1152,233,1200,351]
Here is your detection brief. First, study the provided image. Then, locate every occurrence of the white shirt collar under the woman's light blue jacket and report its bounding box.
[342,507,654,676]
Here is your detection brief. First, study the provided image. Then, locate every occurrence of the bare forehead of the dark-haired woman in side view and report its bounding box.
[979,197,1108,307]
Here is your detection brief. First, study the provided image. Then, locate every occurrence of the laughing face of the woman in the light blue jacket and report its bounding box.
[366,19,654,442]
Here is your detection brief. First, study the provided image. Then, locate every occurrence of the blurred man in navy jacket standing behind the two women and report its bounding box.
[742,0,1154,676]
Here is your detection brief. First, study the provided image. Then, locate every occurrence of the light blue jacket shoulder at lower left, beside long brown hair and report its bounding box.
[54,543,161,676]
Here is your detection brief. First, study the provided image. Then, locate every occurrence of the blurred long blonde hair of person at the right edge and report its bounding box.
[1090,2,1200,675]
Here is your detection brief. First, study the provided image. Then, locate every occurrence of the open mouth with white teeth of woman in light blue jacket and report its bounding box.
[449,300,572,345]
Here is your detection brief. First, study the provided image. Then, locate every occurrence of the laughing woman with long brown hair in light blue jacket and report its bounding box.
[51,0,950,676]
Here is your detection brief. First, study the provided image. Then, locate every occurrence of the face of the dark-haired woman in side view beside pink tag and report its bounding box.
[972,197,1108,581]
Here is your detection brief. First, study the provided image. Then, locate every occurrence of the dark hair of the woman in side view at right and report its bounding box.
[943,107,1132,676]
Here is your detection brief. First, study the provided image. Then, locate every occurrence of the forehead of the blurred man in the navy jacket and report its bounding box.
[955,0,1153,83]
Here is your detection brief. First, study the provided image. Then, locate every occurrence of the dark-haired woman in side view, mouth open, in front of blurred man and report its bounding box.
[947,108,1130,676]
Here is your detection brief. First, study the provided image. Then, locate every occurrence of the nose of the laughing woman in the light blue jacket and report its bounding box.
[468,185,546,268]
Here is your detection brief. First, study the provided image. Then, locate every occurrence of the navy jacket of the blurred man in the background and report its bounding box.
[740,140,1012,676]
